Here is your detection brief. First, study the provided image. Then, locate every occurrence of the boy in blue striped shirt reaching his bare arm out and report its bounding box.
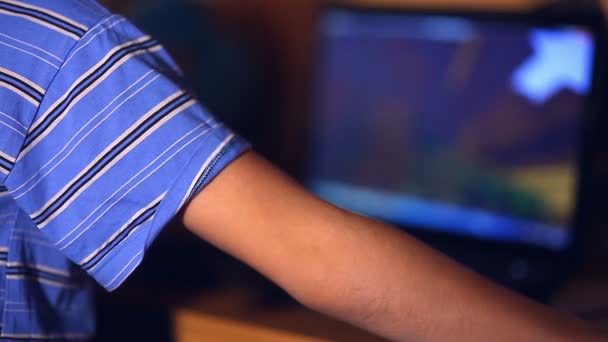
[0,0,602,341]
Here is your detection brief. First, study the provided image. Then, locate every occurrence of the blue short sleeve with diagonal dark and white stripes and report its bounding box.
[5,16,248,290]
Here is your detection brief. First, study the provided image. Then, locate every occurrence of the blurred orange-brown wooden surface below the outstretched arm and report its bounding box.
[173,288,384,342]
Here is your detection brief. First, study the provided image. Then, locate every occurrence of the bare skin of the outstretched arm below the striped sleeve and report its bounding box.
[183,152,606,342]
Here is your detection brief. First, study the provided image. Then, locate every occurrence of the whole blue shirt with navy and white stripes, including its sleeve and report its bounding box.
[0,0,247,340]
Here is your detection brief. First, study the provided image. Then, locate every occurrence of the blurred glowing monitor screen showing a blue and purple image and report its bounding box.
[305,9,594,250]
